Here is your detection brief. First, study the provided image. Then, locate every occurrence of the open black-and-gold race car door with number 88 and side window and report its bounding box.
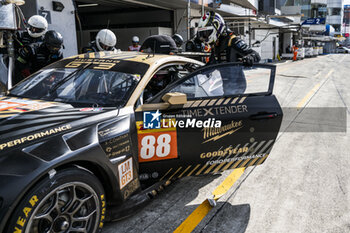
[136,63,283,183]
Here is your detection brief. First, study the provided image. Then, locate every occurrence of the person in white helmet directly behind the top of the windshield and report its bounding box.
[83,29,117,53]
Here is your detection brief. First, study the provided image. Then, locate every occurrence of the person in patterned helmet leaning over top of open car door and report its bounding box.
[197,11,261,66]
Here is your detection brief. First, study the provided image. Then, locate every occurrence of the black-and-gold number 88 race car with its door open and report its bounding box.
[0,52,283,233]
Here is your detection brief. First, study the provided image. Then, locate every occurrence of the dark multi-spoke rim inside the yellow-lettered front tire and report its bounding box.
[25,182,100,233]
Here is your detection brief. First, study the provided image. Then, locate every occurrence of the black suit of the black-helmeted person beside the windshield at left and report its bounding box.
[14,42,63,84]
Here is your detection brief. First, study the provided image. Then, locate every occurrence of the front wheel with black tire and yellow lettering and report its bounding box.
[7,168,106,233]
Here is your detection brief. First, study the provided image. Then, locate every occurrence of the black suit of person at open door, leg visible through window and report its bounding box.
[208,32,261,95]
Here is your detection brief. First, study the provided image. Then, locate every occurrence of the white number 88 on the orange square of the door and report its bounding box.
[140,134,171,159]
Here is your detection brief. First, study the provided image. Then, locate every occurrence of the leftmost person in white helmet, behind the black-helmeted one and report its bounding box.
[14,15,48,50]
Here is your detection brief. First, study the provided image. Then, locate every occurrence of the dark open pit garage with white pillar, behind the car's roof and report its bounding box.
[18,0,174,57]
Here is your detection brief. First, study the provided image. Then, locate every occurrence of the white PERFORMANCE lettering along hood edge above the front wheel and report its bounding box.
[0,124,72,151]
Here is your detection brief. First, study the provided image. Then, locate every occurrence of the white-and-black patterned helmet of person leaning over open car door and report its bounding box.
[197,11,225,44]
